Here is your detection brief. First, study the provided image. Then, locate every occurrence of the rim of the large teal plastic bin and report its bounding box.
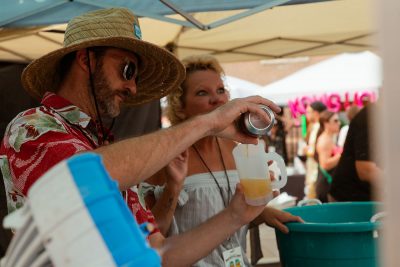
[284,201,382,233]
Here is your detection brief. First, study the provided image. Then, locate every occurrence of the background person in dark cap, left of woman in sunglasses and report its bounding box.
[304,101,326,199]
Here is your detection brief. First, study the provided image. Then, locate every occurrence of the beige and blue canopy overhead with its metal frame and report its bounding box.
[0,0,378,62]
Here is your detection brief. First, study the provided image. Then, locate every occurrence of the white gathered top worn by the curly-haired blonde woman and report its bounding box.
[141,170,251,267]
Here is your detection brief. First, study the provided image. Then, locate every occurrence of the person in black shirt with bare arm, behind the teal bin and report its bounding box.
[328,103,382,202]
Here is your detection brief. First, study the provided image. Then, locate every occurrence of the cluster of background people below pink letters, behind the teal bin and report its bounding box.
[304,101,382,205]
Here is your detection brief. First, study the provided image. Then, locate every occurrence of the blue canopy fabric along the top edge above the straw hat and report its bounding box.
[0,0,329,30]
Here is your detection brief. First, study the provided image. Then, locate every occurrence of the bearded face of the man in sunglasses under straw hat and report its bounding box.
[93,48,138,118]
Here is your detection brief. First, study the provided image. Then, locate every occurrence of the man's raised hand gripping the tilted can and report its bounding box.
[203,96,281,144]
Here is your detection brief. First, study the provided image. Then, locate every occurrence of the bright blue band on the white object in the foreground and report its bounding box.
[67,153,161,267]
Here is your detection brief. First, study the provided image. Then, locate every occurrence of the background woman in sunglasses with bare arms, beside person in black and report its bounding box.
[315,110,341,202]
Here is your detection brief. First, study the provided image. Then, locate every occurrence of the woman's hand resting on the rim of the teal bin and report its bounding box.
[260,207,304,234]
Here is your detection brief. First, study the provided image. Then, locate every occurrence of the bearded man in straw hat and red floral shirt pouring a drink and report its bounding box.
[0,8,300,266]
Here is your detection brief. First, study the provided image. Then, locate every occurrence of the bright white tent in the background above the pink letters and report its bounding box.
[258,51,382,105]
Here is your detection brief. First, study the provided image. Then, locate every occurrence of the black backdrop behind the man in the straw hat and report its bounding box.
[0,63,161,258]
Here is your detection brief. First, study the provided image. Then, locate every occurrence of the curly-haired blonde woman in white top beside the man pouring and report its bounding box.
[142,56,301,267]
